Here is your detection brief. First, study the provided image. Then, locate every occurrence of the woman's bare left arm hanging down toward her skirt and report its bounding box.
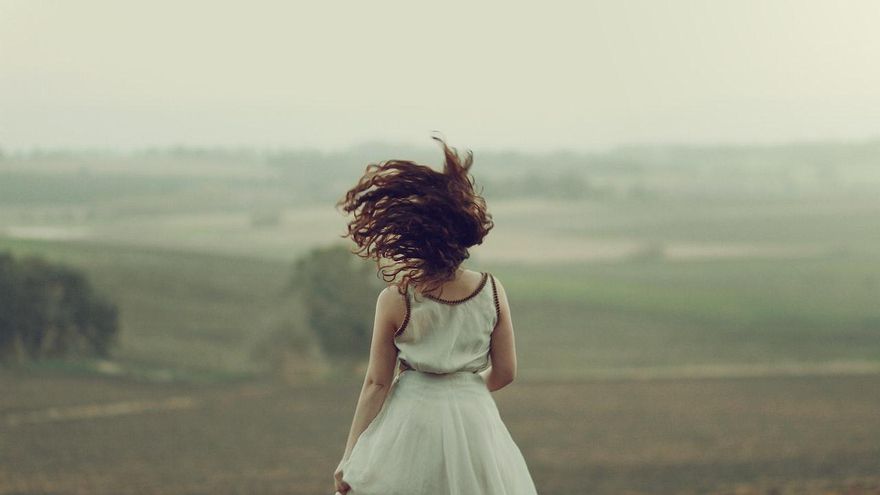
[342,287,406,462]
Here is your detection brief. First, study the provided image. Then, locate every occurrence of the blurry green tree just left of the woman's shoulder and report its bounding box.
[290,245,385,358]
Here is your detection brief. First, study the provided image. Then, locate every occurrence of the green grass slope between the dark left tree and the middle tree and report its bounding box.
[0,238,287,372]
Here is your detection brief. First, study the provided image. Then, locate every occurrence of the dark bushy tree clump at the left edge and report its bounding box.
[0,253,119,361]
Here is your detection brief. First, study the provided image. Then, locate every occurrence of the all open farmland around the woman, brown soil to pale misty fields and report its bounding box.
[0,146,880,494]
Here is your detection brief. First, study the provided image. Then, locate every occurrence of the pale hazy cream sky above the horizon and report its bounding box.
[0,0,880,150]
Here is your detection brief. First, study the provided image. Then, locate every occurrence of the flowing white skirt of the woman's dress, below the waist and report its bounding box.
[342,370,537,495]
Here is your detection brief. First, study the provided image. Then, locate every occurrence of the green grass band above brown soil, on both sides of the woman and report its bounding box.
[0,229,880,377]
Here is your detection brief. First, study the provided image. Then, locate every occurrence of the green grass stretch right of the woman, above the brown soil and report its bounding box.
[484,254,880,375]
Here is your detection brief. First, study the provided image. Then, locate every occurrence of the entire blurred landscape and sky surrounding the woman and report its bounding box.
[0,0,880,494]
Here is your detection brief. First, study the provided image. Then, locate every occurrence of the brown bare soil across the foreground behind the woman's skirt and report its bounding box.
[0,372,880,495]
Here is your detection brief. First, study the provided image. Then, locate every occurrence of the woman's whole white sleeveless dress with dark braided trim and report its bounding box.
[342,272,537,495]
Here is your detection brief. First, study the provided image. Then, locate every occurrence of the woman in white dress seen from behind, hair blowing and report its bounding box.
[334,137,536,495]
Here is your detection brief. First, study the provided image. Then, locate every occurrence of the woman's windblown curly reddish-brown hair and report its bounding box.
[336,136,494,294]
